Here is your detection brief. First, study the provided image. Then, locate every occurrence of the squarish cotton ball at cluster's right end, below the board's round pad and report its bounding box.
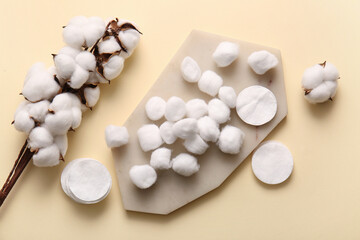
[217,125,245,154]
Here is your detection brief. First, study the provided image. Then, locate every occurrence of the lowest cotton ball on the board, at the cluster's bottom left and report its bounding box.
[129,165,157,189]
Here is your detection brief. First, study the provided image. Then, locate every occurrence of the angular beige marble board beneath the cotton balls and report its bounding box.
[113,30,287,214]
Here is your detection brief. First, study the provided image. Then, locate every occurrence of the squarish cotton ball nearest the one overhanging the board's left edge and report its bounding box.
[137,124,163,152]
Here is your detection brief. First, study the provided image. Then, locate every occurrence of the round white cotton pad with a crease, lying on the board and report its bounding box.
[236,85,277,126]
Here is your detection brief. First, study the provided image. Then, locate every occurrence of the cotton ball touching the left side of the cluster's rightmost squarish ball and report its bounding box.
[198,116,220,142]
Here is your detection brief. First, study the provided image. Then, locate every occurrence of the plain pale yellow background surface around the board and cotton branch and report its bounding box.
[0,0,360,240]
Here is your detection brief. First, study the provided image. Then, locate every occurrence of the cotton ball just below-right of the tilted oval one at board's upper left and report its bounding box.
[198,70,223,97]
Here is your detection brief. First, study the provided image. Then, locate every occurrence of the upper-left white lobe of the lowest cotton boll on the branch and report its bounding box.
[28,127,54,149]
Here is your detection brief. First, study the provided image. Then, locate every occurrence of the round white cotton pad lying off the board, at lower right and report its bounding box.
[252,141,294,184]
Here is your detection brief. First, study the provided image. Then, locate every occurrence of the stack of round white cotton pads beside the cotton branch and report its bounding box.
[61,158,112,204]
